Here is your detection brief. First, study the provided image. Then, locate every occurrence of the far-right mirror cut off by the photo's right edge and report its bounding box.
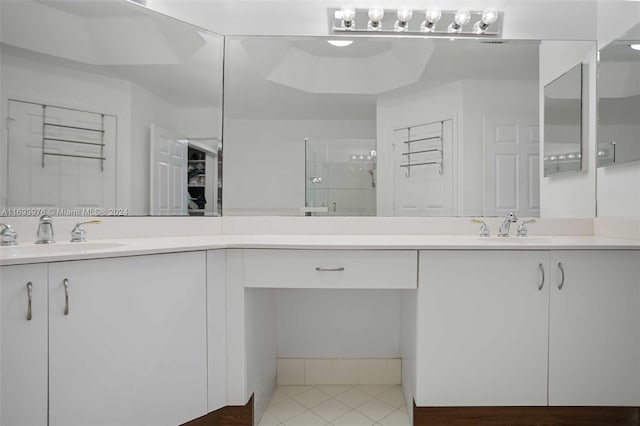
[597,24,640,167]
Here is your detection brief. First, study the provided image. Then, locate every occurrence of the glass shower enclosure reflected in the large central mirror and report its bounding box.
[305,139,376,216]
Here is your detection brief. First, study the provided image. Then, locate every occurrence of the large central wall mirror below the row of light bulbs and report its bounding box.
[224,37,540,217]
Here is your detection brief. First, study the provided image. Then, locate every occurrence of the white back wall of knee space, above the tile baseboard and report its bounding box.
[277,289,401,358]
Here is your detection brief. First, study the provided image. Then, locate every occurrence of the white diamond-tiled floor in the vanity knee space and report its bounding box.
[258,385,409,426]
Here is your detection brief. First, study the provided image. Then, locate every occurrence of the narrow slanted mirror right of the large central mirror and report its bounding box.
[544,64,582,176]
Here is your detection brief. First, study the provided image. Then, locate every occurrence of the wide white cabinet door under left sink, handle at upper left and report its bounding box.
[49,252,207,426]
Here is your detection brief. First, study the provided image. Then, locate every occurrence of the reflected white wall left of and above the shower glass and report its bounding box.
[223,119,375,216]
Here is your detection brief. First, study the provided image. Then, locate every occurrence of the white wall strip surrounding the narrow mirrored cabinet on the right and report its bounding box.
[540,41,596,218]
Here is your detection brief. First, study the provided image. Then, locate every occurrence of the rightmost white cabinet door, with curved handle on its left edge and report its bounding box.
[549,251,640,406]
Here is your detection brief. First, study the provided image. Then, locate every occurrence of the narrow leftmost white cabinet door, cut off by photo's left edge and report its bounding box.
[0,265,48,426]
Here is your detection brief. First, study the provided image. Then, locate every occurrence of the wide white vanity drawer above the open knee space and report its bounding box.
[244,249,418,289]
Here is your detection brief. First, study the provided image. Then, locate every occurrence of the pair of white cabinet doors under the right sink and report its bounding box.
[416,250,640,406]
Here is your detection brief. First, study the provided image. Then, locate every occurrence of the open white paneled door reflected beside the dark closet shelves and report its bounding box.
[149,124,189,216]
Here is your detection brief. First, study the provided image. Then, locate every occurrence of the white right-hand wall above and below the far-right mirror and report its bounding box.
[597,0,640,217]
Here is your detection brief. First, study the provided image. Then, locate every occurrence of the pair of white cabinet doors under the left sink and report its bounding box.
[0,251,208,426]
